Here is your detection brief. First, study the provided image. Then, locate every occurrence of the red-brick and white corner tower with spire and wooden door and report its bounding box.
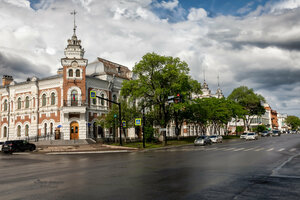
[61,10,88,140]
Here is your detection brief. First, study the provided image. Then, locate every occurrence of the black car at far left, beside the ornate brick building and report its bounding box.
[2,140,36,153]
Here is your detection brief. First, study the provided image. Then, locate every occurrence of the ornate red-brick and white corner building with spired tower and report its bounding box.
[0,25,132,141]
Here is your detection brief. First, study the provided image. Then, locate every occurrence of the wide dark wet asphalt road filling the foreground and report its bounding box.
[0,135,300,200]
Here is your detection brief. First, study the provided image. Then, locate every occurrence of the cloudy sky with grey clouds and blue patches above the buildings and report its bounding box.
[0,0,300,116]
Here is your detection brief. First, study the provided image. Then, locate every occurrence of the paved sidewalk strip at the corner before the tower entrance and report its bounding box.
[36,144,138,153]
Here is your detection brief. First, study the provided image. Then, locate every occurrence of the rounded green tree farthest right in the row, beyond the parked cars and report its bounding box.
[228,86,265,130]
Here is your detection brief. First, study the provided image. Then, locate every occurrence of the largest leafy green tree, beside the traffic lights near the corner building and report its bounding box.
[121,53,192,145]
